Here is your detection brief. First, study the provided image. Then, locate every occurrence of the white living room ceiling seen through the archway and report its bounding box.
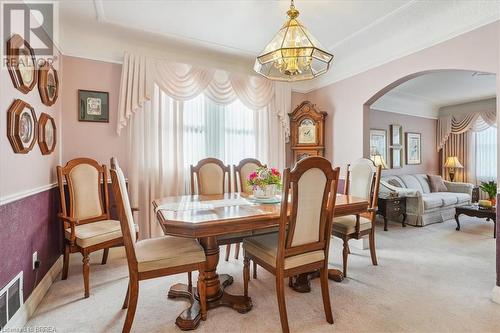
[372,70,496,118]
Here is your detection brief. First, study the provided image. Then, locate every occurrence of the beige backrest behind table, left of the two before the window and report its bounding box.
[191,158,231,195]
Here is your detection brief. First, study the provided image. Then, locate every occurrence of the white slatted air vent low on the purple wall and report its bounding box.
[0,272,23,331]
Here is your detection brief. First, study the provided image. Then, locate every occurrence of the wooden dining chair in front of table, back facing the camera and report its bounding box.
[243,157,339,332]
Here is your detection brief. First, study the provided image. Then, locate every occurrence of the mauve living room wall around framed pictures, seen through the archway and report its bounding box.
[369,110,439,176]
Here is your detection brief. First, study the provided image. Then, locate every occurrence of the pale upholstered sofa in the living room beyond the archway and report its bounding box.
[379,174,474,227]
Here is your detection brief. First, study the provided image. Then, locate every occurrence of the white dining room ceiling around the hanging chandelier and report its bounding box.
[59,0,500,92]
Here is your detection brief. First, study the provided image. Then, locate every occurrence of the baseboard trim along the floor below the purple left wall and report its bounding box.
[5,256,63,330]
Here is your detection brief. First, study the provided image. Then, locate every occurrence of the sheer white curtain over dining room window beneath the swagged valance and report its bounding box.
[128,86,270,238]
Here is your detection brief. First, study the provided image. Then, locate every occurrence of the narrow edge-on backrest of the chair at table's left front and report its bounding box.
[110,157,137,265]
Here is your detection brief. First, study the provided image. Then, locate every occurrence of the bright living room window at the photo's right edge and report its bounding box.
[475,127,497,182]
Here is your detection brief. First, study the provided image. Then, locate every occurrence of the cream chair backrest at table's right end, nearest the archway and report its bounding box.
[345,158,382,208]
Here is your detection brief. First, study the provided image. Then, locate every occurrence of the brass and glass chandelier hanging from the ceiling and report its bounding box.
[254,0,333,81]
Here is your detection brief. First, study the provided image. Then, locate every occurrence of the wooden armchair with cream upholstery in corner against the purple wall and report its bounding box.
[57,158,123,298]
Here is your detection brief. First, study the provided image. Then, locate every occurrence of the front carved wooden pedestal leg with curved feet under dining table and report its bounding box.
[168,237,252,330]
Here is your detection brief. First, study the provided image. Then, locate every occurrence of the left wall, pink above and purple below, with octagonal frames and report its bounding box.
[0,48,63,300]
